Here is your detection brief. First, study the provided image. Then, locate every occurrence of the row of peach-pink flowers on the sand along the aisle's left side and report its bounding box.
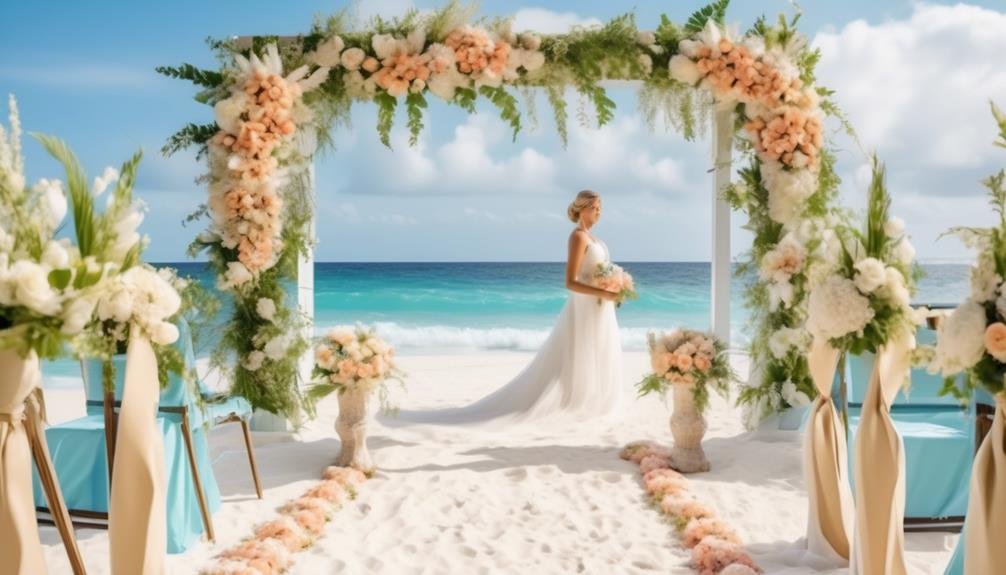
[201,466,366,575]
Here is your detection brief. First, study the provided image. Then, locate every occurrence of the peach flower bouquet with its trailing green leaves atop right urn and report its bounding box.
[636,330,736,413]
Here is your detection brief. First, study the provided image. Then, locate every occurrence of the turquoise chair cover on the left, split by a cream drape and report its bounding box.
[34,320,221,553]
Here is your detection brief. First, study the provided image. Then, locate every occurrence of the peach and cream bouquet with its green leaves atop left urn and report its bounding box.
[308,326,401,410]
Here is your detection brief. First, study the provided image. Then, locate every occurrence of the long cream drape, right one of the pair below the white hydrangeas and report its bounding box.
[851,341,909,575]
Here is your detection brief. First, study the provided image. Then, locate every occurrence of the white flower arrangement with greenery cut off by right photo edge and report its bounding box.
[930,105,1006,400]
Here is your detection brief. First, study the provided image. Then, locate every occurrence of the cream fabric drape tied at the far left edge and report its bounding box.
[0,350,45,575]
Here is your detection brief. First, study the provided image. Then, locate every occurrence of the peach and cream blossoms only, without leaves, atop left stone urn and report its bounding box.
[315,328,395,387]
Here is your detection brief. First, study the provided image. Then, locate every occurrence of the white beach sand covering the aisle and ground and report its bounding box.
[35,353,957,574]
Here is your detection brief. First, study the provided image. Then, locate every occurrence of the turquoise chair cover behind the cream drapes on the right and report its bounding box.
[845,328,975,519]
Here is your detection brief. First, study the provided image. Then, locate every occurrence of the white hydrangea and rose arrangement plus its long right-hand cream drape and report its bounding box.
[805,158,926,573]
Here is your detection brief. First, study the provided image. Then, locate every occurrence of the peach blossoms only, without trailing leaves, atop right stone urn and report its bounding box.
[650,330,726,384]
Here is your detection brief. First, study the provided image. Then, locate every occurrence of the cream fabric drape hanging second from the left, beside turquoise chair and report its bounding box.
[109,337,167,575]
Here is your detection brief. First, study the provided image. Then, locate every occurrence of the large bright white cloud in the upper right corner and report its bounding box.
[814,4,1006,168]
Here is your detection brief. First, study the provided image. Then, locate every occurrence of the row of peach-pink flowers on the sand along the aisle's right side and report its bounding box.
[621,441,762,575]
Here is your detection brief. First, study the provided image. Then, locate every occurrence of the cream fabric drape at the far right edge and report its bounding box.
[964,393,1006,575]
